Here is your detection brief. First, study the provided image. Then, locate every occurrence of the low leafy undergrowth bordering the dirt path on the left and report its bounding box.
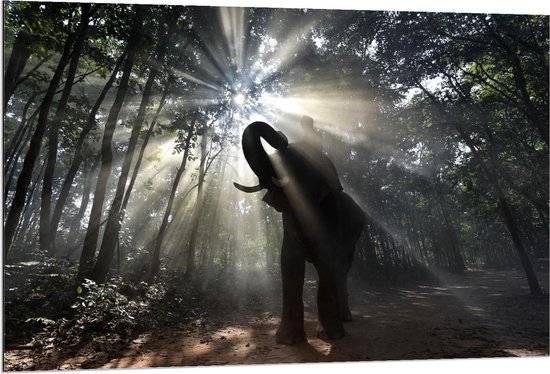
[4,259,278,354]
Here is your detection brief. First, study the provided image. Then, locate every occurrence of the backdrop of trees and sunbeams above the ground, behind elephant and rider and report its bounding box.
[3,1,549,293]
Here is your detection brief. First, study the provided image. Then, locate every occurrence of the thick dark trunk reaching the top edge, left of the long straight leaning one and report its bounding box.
[78,5,147,278]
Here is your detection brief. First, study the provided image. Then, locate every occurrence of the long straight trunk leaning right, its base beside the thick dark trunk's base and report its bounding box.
[91,11,175,283]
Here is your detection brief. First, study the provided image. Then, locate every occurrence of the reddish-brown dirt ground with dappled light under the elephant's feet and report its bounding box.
[4,270,549,370]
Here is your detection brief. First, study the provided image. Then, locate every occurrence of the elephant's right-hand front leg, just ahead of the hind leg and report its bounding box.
[316,257,346,339]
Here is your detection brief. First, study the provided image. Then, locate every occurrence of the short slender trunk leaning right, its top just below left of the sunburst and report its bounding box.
[149,118,196,280]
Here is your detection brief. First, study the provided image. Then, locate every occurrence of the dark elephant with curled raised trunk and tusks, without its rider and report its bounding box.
[234,121,366,345]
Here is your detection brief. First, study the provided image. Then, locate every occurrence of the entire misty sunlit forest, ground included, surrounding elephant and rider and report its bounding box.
[2,1,550,370]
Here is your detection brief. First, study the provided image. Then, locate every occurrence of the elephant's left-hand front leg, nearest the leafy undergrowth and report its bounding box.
[276,233,306,344]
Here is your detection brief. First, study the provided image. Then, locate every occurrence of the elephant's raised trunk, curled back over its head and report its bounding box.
[242,121,288,188]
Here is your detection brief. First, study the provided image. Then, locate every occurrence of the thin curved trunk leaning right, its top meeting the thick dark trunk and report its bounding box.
[51,51,126,245]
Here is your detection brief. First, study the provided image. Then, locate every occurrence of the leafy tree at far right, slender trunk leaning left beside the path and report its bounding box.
[379,10,548,294]
